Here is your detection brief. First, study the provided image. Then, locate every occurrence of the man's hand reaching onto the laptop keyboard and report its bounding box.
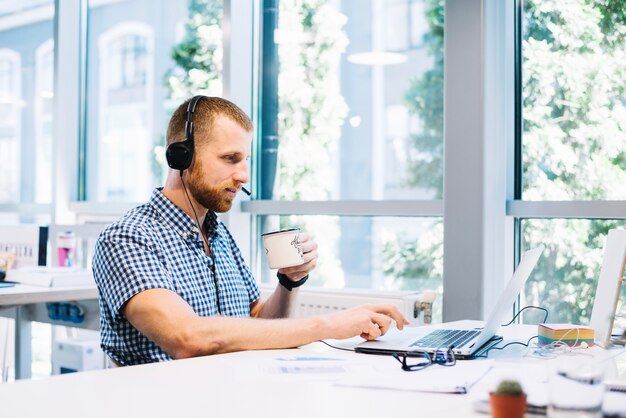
[323,303,409,340]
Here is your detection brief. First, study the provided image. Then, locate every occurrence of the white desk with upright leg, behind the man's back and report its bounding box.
[0,284,100,379]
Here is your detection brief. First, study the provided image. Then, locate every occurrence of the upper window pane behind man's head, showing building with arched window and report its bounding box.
[86,0,222,202]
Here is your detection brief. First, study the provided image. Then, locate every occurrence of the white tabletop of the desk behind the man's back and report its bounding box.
[0,284,98,307]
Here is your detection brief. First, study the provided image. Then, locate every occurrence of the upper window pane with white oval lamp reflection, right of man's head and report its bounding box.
[259,0,443,200]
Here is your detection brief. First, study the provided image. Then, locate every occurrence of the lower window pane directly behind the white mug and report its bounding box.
[257,216,443,322]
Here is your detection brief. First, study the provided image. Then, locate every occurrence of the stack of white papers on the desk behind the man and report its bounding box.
[6,266,95,287]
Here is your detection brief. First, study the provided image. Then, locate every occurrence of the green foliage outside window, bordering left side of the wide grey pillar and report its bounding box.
[382,0,444,292]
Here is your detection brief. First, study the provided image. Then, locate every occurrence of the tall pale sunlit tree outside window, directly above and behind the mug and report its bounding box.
[274,0,348,287]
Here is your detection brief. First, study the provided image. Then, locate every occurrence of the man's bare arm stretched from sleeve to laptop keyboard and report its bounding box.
[122,289,408,358]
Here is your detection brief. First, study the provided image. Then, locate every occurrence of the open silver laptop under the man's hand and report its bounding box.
[355,246,543,359]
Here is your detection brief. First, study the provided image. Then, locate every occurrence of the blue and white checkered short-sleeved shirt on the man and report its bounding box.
[93,189,260,365]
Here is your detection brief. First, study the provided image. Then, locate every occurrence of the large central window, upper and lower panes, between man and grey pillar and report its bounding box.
[241,0,443,322]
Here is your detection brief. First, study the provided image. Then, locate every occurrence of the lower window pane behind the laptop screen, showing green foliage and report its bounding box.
[522,219,626,327]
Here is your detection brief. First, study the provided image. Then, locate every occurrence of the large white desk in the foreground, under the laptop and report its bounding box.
[0,326,626,418]
